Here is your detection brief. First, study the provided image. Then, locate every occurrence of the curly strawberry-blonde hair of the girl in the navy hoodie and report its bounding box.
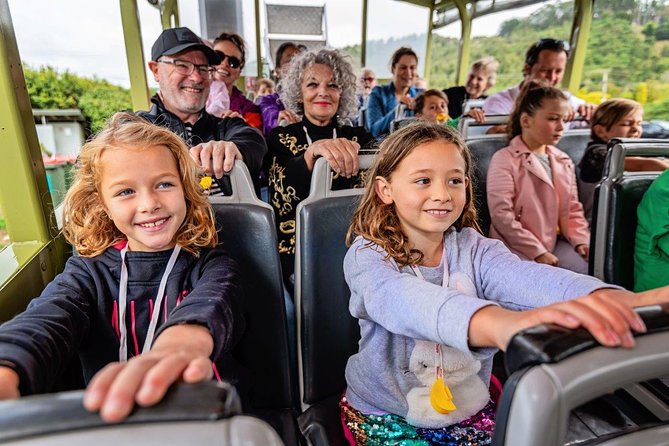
[63,113,218,257]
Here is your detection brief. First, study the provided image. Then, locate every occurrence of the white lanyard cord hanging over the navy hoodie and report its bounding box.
[118,243,181,362]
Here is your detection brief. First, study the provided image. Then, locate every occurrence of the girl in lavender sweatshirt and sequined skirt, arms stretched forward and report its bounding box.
[340,123,669,445]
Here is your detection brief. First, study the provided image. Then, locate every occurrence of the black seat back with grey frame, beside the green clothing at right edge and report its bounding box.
[590,139,669,289]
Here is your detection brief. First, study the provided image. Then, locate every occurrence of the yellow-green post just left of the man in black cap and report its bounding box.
[120,0,149,110]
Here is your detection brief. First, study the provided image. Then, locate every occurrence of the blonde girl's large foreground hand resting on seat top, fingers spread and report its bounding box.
[84,325,214,423]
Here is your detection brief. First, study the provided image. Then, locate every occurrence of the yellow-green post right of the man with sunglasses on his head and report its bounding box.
[562,0,594,93]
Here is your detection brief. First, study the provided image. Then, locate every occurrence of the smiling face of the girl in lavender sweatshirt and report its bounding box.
[375,140,469,252]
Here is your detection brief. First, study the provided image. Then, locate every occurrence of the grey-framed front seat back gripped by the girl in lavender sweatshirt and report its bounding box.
[493,305,669,446]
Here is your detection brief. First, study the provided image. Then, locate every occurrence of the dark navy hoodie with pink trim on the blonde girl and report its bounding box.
[0,247,244,395]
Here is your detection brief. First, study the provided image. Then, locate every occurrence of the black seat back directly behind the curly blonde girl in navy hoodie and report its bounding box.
[210,161,297,409]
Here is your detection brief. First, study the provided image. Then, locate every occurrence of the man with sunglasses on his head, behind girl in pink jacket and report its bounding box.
[483,39,594,133]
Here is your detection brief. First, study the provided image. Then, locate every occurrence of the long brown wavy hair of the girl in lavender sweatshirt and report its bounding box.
[346,121,481,266]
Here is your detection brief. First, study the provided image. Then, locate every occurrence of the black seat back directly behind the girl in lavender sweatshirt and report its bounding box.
[295,155,374,408]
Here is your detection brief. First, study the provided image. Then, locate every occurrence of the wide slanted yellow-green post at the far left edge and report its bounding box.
[0,0,52,243]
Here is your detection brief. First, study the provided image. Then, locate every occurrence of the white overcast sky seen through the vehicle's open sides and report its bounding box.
[9,0,539,86]
